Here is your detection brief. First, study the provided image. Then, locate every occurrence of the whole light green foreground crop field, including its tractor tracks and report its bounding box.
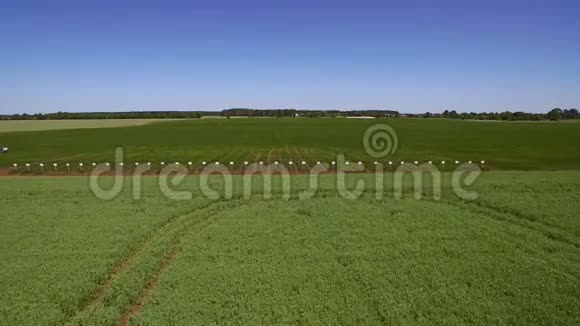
[0,171,580,325]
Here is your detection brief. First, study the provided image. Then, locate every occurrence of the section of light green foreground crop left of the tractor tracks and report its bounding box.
[0,178,212,325]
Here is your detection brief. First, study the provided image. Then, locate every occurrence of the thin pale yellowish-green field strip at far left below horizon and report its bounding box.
[0,119,174,133]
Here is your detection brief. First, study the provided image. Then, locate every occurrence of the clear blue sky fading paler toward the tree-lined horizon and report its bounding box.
[0,0,580,113]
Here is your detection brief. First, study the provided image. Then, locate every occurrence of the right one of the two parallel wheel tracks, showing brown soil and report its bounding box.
[118,204,245,326]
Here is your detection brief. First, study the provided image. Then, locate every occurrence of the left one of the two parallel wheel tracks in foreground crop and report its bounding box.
[63,203,220,325]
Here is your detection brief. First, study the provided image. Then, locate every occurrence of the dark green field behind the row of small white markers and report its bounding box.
[0,119,580,170]
